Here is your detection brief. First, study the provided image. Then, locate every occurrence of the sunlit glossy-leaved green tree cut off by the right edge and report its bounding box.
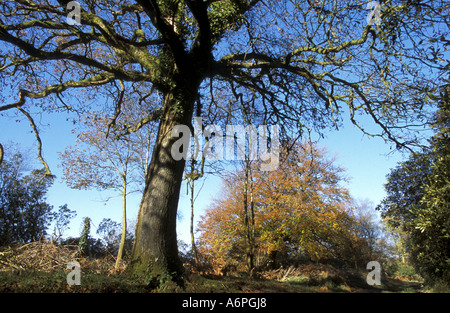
[411,85,450,284]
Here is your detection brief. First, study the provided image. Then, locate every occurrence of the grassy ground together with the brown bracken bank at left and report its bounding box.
[0,242,436,293]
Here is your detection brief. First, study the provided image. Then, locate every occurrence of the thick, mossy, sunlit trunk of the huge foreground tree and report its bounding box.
[130,81,198,282]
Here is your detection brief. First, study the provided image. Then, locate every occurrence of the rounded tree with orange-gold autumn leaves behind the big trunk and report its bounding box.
[198,143,359,268]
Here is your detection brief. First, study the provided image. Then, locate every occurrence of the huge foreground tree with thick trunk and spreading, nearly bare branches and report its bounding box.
[0,0,448,278]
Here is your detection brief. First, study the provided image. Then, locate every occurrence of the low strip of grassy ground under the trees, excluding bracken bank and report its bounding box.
[0,270,423,293]
